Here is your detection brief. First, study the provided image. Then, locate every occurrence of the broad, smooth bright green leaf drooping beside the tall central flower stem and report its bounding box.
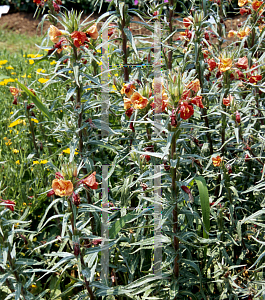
[195,176,210,239]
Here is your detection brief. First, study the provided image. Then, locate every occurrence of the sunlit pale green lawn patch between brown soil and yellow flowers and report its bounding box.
[0,26,43,53]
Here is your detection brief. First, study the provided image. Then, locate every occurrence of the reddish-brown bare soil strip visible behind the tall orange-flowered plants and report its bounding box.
[0,12,245,36]
